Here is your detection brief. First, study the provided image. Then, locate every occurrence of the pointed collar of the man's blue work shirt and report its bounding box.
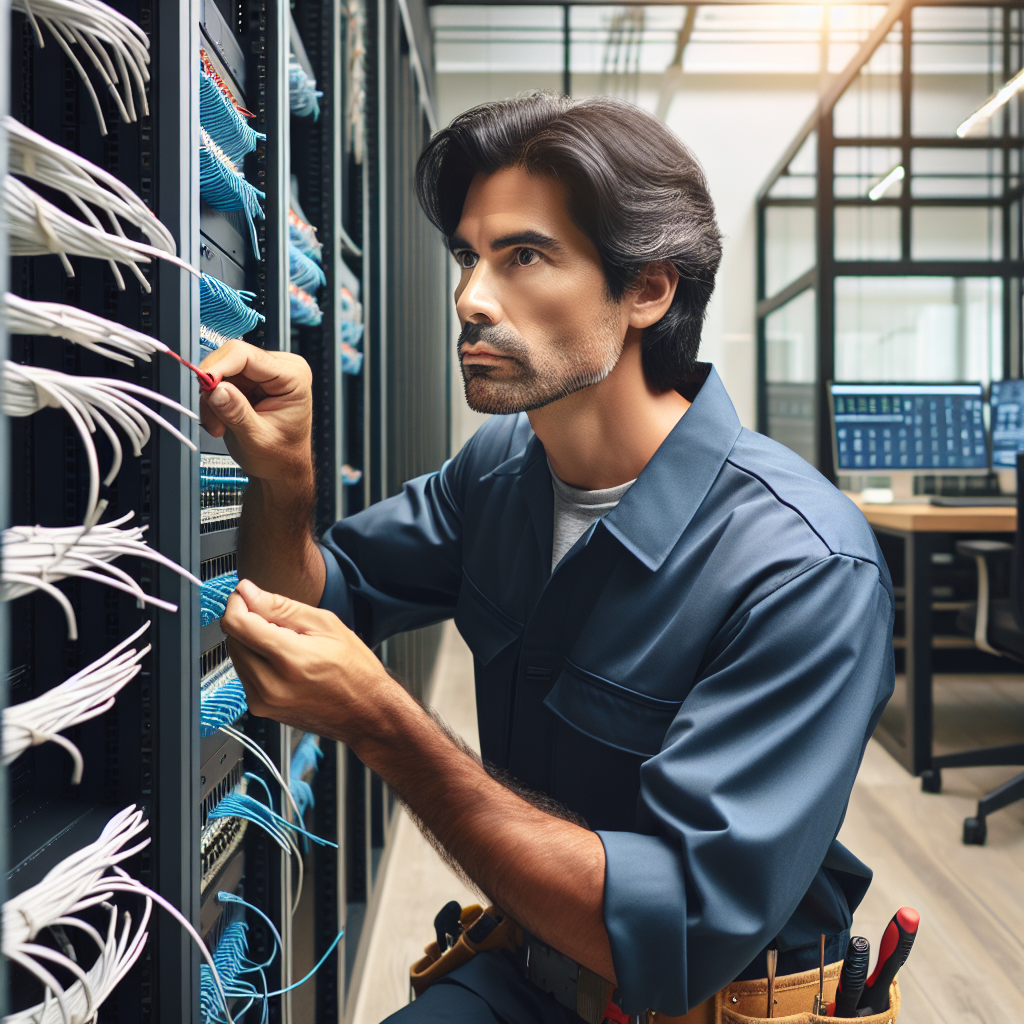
[488,364,741,570]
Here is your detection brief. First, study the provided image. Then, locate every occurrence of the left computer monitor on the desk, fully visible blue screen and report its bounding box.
[828,383,988,476]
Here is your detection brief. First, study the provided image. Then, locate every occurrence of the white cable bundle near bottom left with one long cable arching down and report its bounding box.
[2,804,231,1024]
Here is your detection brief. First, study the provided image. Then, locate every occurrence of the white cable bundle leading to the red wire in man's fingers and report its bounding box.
[4,292,170,367]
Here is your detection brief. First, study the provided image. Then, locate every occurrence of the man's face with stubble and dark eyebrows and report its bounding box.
[450,168,629,414]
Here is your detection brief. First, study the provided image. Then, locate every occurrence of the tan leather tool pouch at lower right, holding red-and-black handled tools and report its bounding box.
[647,961,900,1024]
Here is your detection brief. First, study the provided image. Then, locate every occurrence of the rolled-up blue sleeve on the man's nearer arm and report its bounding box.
[598,554,894,1015]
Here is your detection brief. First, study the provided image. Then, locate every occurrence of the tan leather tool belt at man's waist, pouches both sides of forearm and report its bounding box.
[409,903,900,1024]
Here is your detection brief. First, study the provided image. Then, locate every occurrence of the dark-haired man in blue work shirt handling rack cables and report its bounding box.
[203,94,893,1024]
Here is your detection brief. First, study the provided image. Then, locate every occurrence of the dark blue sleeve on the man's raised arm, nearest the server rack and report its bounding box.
[321,458,465,646]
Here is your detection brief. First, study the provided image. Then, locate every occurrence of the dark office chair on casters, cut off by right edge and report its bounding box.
[937,453,1024,846]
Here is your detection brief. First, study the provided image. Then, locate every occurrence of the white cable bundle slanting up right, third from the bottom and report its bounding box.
[0,623,152,785]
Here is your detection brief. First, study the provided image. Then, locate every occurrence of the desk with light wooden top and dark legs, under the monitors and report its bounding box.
[848,495,1017,775]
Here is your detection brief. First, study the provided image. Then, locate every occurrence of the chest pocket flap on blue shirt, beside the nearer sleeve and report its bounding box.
[544,660,682,759]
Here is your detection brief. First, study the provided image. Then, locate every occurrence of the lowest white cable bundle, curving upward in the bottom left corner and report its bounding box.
[3,898,153,1024]
